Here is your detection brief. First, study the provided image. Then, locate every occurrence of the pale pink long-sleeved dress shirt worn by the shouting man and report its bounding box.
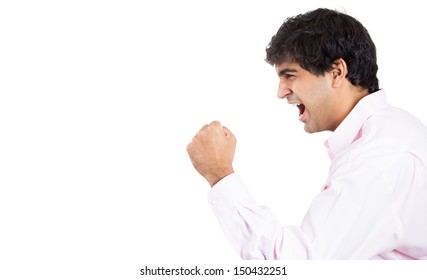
[208,90,427,260]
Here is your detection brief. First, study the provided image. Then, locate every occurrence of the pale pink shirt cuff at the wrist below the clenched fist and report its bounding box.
[208,173,256,218]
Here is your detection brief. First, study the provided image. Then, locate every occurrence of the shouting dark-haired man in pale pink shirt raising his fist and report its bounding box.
[187,9,427,259]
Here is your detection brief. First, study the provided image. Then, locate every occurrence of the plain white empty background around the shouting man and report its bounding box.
[0,0,427,279]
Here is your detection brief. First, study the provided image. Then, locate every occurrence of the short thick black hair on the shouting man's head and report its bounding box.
[266,8,379,93]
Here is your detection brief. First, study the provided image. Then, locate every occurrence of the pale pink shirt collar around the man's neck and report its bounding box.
[325,90,387,159]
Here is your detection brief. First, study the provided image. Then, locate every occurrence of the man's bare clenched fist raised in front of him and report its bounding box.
[187,121,236,187]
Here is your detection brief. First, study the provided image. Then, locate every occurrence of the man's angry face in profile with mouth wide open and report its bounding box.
[276,62,340,133]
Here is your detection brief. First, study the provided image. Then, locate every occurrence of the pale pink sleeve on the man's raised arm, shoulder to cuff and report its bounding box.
[208,156,409,260]
